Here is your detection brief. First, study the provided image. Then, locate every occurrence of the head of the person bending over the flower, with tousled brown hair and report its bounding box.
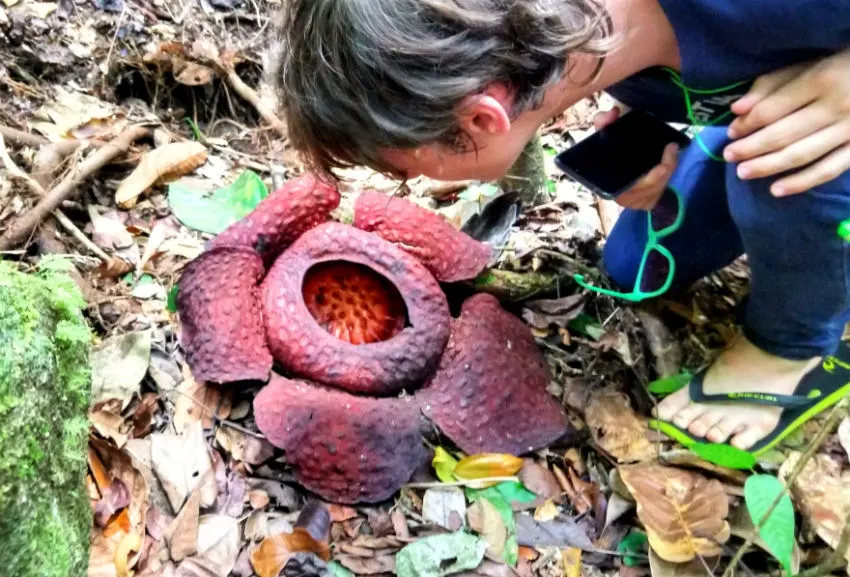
[275,0,612,180]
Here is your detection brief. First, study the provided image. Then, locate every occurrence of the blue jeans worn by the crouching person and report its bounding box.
[603,127,850,359]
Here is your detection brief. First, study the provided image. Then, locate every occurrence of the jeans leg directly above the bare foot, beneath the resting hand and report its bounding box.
[727,165,850,359]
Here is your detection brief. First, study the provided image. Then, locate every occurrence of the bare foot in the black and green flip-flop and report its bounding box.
[657,336,820,449]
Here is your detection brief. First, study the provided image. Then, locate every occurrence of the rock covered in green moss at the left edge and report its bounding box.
[0,259,92,577]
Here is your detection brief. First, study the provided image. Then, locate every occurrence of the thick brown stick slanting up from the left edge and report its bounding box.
[0,125,150,250]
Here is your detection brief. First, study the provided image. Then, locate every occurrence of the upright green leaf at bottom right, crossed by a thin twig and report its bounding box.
[744,475,794,575]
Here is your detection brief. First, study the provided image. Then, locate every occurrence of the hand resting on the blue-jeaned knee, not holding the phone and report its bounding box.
[723,50,850,196]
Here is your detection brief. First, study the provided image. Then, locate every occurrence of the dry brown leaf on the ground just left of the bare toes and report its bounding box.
[584,389,656,463]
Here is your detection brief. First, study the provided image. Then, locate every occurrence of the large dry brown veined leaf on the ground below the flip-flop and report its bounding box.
[619,464,730,563]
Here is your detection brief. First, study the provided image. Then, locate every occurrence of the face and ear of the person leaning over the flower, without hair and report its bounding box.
[382,88,540,181]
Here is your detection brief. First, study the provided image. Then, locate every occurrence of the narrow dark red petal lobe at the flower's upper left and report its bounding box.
[210,173,340,266]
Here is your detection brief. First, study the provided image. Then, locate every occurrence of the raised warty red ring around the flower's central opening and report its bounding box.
[262,222,451,395]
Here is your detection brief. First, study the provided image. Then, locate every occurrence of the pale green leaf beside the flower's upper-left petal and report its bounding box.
[168,170,269,234]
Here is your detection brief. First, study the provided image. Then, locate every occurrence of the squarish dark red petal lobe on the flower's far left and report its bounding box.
[177,248,272,383]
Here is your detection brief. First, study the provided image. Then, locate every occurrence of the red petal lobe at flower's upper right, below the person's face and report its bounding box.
[354,192,492,282]
